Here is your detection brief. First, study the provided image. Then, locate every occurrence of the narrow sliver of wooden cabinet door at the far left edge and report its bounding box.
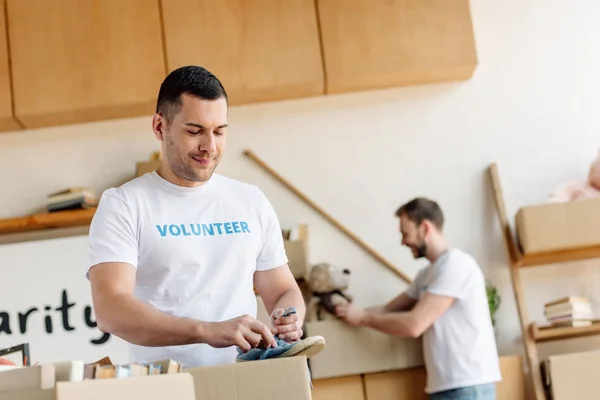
[0,0,20,132]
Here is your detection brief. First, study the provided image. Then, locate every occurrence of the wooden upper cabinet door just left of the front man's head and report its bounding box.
[6,0,166,128]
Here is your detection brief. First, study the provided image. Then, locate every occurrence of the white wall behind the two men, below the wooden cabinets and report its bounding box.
[0,0,600,364]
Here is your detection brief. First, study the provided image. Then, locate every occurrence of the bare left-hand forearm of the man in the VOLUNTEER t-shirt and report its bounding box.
[96,295,204,347]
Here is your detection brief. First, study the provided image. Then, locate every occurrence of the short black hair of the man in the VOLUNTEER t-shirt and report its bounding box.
[156,65,228,122]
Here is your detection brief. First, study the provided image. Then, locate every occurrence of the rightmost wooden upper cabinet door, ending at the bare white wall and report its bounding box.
[316,0,477,93]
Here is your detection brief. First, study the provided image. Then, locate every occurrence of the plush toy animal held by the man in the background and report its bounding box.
[305,263,352,321]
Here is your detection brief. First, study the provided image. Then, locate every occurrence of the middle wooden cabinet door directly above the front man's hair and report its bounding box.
[162,0,324,105]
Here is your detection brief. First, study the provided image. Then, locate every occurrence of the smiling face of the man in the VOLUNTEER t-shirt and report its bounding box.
[157,94,227,185]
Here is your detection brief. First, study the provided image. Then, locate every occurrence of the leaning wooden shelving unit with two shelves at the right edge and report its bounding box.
[488,163,600,400]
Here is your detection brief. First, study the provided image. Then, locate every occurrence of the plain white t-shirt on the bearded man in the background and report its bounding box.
[406,249,502,393]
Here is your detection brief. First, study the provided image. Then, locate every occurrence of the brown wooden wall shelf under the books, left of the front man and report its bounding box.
[0,208,96,235]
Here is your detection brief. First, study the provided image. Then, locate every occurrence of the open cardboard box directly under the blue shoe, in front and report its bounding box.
[185,356,311,400]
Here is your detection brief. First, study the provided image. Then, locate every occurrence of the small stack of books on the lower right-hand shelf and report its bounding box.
[544,296,593,327]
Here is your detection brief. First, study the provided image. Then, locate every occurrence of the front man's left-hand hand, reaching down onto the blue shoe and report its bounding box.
[202,315,277,351]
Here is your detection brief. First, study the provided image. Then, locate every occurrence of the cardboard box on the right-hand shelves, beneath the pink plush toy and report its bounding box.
[515,198,600,254]
